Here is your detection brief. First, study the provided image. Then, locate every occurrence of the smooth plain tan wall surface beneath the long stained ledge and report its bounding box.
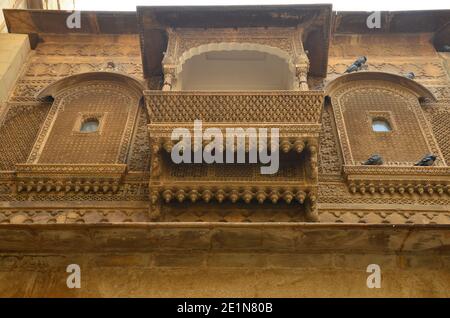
[0,252,450,297]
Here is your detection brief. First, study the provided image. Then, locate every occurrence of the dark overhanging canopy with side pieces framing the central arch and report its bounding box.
[137,4,332,77]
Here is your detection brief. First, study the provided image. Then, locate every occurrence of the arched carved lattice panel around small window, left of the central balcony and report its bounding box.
[28,82,139,164]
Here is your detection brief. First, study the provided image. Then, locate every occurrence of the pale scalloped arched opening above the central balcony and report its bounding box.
[174,43,295,91]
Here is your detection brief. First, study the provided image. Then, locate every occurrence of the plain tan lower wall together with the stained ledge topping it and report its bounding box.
[0,224,450,297]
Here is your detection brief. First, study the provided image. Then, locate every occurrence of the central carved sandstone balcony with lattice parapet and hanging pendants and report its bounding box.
[145,91,323,221]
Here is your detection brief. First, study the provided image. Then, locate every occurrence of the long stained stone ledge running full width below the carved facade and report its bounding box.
[0,223,450,254]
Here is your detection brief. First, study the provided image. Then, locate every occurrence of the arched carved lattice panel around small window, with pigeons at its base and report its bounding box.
[332,81,445,166]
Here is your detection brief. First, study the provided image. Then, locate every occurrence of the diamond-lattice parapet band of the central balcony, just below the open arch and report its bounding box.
[146,91,323,124]
